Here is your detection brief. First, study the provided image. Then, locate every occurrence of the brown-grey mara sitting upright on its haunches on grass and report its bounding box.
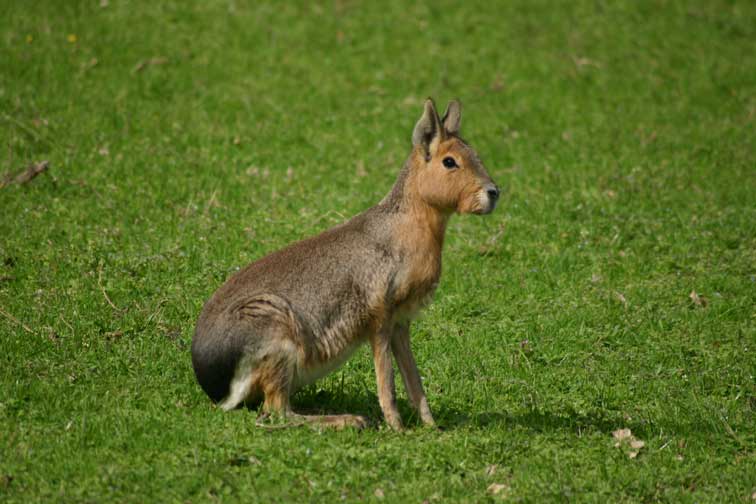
[192,100,498,429]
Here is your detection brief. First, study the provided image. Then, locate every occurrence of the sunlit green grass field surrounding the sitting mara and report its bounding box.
[0,0,756,503]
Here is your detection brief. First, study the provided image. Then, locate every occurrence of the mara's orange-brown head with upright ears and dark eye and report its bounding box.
[412,99,499,214]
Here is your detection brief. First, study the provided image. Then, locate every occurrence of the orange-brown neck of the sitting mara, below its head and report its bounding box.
[380,149,451,254]
